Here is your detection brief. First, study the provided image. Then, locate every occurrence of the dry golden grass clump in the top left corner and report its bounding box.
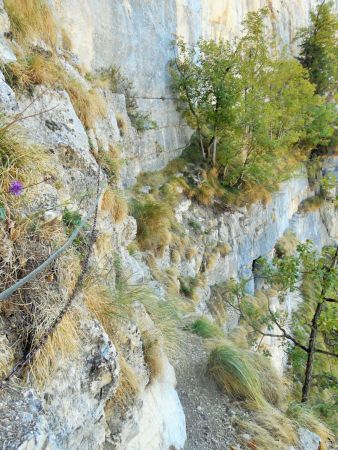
[4,0,56,47]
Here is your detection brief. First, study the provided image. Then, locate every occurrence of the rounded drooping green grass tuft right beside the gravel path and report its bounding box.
[208,344,264,407]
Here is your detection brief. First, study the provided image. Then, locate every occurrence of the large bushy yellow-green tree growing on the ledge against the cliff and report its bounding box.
[171,9,334,190]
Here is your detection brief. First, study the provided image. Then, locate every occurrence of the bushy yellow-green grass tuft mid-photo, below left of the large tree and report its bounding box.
[131,196,173,255]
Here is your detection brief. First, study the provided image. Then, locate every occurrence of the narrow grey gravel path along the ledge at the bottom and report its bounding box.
[174,334,240,450]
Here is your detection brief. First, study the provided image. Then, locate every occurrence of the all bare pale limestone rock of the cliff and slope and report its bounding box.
[0,0,337,450]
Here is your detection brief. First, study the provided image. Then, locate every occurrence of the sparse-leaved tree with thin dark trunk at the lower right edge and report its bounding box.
[225,242,338,402]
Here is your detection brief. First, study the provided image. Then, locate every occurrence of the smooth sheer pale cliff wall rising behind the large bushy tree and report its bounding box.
[50,0,315,184]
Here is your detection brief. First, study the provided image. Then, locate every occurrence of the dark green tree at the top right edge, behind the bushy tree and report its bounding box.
[297,0,338,95]
